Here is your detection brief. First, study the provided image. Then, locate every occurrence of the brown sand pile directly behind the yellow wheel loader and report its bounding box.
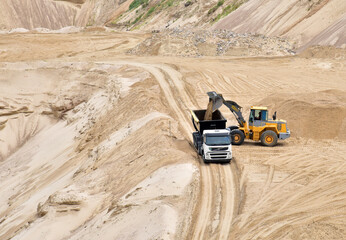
[260,90,346,140]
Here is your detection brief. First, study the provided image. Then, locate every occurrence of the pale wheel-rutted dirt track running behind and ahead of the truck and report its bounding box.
[101,62,236,239]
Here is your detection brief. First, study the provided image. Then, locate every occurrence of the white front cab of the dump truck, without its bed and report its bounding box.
[202,129,232,163]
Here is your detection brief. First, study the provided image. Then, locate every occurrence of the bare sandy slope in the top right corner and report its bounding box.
[213,0,346,48]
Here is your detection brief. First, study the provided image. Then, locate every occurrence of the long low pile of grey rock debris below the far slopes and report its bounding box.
[128,28,295,57]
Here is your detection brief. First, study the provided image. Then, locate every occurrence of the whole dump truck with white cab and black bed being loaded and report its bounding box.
[191,109,232,163]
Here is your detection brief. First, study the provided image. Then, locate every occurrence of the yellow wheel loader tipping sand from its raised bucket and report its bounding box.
[207,91,290,147]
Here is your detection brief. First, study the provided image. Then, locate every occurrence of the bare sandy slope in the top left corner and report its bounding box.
[0,0,129,30]
